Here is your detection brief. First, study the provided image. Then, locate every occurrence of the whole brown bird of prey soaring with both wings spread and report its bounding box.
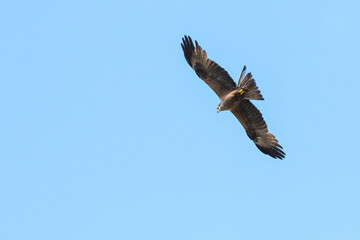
[181,36,285,160]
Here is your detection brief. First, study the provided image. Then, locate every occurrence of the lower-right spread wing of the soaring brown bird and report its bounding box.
[231,99,285,159]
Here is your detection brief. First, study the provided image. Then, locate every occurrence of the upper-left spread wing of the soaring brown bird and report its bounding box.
[181,36,236,99]
